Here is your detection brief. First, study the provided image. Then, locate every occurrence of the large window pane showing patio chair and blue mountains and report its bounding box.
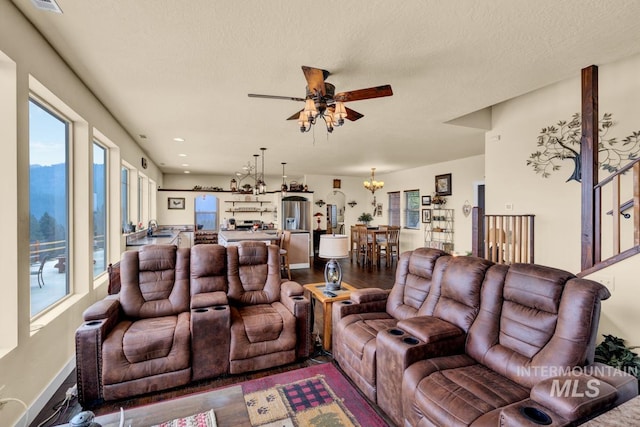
[29,98,71,317]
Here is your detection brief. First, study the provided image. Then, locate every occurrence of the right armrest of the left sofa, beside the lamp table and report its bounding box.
[280,290,312,358]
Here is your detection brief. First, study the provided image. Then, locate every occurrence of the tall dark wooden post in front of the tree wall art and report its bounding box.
[580,65,600,270]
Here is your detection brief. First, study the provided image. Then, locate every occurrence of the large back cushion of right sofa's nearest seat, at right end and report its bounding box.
[467,264,609,387]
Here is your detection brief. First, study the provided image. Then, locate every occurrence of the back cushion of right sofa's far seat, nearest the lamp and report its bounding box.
[387,248,448,320]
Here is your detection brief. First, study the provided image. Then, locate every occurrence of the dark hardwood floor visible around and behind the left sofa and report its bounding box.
[30,259,397,427]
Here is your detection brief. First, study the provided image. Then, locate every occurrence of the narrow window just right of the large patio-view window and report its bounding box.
[93,141,107,277]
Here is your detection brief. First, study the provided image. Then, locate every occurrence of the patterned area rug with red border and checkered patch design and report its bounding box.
[241,363,387,427]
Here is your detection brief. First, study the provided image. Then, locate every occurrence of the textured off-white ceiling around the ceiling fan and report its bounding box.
[13,0,640,176]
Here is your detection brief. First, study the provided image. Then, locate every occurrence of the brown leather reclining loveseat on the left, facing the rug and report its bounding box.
[76,242,311,406]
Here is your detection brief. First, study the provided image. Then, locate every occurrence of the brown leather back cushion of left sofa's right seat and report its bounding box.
[227,241,281,305]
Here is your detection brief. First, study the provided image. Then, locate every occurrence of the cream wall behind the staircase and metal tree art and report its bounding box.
[485,56,640,345]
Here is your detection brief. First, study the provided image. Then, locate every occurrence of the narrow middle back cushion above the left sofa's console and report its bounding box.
[191,244,227,295]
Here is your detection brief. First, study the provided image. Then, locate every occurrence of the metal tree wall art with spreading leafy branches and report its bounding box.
[527,113,640,182]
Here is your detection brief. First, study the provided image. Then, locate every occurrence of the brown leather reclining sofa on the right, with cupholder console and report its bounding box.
[332,248,638,427]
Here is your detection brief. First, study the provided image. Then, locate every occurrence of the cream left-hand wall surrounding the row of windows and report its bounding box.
[0,1,162,426]
